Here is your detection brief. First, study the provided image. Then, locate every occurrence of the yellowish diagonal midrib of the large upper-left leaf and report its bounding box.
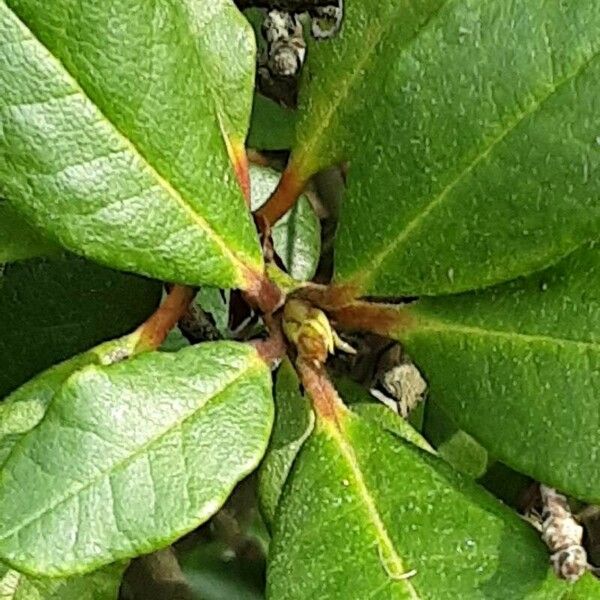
[3,2,255,284]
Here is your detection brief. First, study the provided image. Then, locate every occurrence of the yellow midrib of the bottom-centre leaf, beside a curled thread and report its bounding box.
[327,420,421,600]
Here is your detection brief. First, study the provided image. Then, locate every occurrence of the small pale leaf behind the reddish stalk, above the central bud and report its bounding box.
[250,165,321,281]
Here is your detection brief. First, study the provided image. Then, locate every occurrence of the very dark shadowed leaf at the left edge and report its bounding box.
[0,254,162,398]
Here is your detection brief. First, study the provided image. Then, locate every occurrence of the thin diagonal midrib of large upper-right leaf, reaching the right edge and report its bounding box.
[352,45,600,290]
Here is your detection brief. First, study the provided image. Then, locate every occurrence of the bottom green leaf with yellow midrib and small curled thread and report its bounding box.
[268,413,567,600]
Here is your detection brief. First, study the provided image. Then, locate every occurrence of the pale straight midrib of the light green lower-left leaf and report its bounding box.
[0,359,263,542]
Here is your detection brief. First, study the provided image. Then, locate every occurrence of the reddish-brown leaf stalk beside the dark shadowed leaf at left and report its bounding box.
[136,285,195,352]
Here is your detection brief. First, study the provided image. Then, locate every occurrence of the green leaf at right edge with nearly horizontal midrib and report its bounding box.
[396,245,600,503]
